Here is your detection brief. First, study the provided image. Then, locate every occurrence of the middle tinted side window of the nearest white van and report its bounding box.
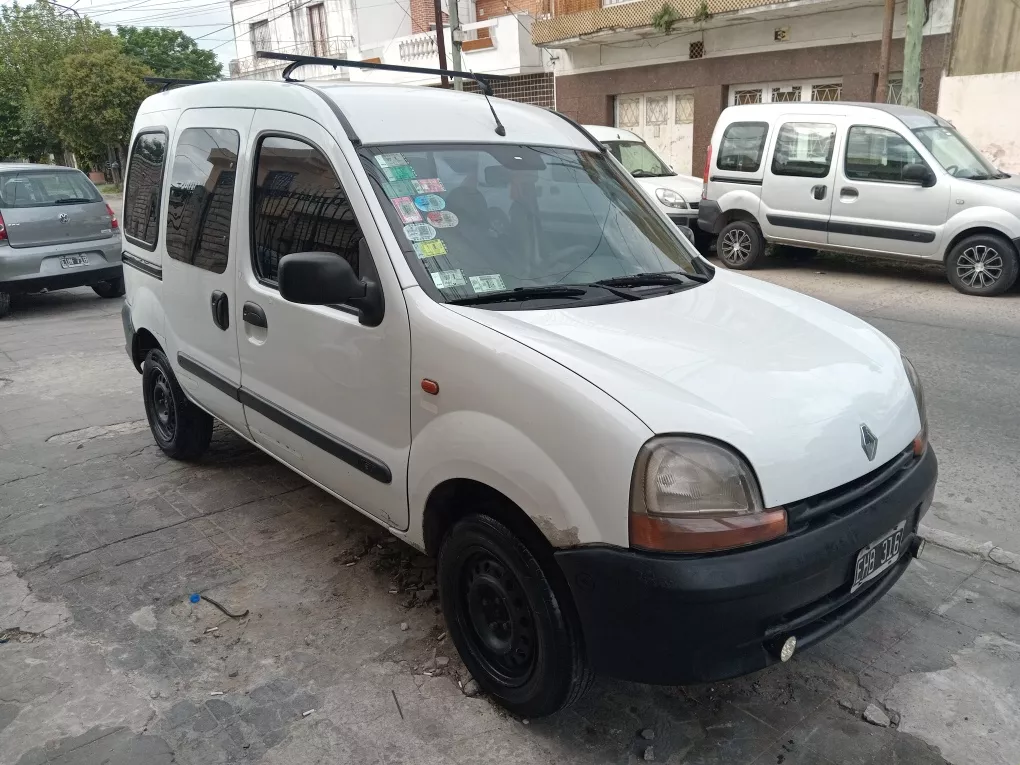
[166,128,241,273]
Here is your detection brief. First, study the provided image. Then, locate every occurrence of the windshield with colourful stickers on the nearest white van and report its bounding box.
[365,145,711,307]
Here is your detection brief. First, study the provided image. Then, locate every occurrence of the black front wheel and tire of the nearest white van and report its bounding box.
[438,514,594,718]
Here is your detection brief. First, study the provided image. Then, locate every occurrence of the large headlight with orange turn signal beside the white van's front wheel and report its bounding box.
[630,436,786,553]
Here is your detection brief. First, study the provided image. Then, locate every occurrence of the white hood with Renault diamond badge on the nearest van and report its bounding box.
[451,270,920,507]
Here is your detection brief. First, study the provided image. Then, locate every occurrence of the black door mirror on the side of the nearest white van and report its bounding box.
[277,239,384,326]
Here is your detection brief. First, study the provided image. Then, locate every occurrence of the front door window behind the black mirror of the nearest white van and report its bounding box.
[252,136,362,284]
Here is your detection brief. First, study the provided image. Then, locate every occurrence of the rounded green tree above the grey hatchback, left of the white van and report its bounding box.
[32,49,152,158]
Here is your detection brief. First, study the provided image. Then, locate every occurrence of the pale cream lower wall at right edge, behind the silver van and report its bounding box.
[938,71,1020,172]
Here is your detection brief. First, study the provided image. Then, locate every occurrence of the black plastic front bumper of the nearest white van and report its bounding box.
[556,448,938,684]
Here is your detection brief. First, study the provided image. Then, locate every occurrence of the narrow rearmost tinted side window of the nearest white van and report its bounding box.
[123,133,166,250]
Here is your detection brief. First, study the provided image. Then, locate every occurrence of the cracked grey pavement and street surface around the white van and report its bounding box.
[0,235,1020,765]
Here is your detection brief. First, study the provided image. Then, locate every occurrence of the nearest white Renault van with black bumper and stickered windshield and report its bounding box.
[123,68,937,717]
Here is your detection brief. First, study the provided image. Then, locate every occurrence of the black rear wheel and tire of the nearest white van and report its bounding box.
[142,348,212,460]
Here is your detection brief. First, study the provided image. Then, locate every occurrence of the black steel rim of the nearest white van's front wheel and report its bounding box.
[460,550,539,687]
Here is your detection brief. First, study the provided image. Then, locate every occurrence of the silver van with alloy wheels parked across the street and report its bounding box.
[698,103,1020,296]
